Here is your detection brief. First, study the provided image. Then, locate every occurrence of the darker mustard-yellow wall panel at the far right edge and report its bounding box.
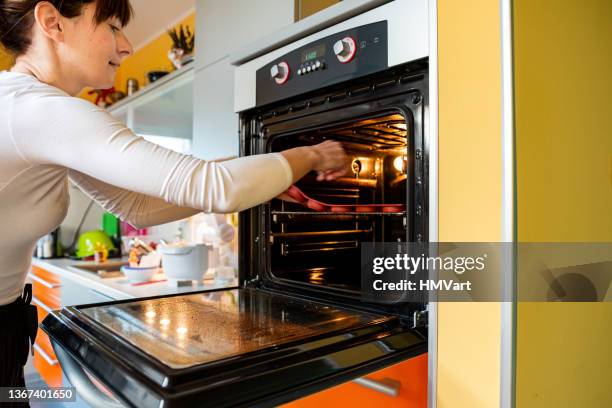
[513,0,612,408]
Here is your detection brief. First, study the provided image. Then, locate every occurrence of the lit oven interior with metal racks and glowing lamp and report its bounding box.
[268,111,413,296]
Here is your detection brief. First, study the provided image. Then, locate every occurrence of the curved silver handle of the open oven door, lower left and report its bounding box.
[52,342,125,408]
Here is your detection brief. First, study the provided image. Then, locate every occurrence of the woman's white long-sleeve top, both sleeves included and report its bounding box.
[0,71,293,305]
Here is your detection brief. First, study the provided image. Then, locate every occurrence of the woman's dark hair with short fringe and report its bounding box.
[0,0,134,56]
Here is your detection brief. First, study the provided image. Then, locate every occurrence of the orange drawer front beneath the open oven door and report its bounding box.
[283,354,427,408]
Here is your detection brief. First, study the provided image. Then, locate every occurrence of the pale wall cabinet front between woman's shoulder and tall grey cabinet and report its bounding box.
[107,64,194,144]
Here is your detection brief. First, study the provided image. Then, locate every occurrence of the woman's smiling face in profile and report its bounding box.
[58,2,133,89]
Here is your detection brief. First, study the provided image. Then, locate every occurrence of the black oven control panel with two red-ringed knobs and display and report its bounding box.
[256,21,388,106]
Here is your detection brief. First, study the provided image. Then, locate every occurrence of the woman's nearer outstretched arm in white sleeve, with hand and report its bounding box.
[11,84,346,220]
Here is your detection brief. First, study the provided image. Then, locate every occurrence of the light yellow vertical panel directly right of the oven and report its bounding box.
[437,0,502,408]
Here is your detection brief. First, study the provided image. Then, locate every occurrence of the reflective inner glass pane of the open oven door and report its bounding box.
[81,289,389,368]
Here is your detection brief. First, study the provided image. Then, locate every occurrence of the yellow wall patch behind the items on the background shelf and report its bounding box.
[80,13,195,100]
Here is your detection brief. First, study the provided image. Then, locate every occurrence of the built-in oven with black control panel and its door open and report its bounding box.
[42,0,428,407]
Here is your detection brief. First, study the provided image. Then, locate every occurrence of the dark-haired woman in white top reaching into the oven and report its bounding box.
[0,0,347,386]
